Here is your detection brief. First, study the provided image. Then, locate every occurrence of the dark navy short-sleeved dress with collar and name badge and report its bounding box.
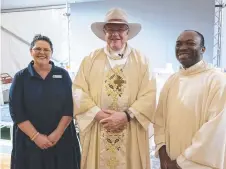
[9,62,80,169]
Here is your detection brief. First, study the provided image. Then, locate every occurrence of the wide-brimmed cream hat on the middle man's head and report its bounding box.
[91,8,141,41]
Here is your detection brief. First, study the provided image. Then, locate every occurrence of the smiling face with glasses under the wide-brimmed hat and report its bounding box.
[104,24,129,51]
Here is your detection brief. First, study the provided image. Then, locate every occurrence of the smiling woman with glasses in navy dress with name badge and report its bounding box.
[10,35,80,169]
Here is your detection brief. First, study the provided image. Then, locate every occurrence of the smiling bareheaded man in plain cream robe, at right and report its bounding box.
[154,30,226,169]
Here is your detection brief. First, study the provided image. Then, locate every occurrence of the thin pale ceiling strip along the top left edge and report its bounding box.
[1,0,100,9]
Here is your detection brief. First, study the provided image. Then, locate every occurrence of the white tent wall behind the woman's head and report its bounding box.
[1,9,69,76]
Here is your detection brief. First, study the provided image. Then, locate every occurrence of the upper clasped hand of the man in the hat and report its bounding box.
[100,110,128,132]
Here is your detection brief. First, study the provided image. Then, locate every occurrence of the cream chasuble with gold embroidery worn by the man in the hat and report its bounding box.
[73,45,156,169]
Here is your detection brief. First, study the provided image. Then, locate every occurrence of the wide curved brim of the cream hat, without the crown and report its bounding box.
[91,22,141,41]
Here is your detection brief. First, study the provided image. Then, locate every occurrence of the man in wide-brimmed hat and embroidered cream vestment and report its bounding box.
[73,8,156,169]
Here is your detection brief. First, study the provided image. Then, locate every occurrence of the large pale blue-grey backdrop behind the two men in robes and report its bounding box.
[71,0,214,71]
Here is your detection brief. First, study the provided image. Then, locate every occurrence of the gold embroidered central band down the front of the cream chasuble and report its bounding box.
[100,66,127,169]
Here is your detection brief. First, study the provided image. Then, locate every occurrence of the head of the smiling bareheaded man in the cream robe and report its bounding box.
[176,31,205,68]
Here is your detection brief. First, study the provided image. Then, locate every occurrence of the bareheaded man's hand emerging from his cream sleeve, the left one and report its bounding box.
[159,145,171,169]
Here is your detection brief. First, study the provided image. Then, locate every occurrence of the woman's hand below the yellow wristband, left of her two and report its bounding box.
[34,134,53,149]
